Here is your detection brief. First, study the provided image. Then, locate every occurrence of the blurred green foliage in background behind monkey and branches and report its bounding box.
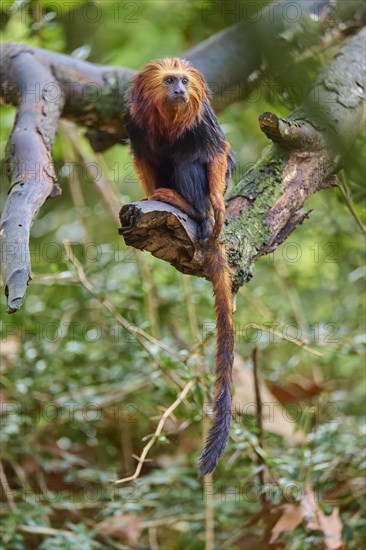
[0,0,365,550]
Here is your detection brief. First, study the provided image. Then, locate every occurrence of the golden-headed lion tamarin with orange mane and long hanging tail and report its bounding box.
[124,57,235,476]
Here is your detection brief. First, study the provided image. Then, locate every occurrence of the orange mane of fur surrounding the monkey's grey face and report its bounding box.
[126,57,210,141]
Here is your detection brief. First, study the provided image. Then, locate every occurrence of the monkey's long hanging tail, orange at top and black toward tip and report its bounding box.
[198,241,234,477]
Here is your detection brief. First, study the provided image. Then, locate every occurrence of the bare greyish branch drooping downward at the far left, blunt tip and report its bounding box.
[0,51,64,313]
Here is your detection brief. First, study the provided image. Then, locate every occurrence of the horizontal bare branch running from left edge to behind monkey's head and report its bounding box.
[0,44,135,152]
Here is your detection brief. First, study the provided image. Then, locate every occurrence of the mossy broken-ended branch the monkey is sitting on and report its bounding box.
[120,29,366,289]
